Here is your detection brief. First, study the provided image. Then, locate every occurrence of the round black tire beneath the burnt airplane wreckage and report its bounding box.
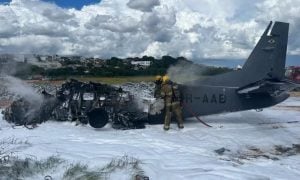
[87,109,108,128]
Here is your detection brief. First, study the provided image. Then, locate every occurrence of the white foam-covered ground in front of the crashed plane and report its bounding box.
[0,97,300,180]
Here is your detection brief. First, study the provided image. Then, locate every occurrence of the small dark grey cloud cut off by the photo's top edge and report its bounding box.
[127,0,160,12]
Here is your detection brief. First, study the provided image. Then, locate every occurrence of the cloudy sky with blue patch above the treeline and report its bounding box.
[0,0,300,63]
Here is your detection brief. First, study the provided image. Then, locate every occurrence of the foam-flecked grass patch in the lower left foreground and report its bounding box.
[0,137,146,180]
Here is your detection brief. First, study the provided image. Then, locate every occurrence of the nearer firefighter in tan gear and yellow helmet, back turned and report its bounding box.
[161,76,184,131]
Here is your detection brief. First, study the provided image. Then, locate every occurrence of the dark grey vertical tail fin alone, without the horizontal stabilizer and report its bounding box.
[242,22,289,82]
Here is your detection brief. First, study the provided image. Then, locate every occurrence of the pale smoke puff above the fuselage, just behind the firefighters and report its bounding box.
[167,61,206,84]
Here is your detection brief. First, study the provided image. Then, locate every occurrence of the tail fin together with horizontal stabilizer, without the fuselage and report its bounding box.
[237,22,299,96]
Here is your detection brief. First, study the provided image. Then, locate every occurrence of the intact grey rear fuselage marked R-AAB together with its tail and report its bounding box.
[181,22,297,117]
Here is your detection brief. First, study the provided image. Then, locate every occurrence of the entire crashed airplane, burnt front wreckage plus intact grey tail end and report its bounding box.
[5,22,300,129]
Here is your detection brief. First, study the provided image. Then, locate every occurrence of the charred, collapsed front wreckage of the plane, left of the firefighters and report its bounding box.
[3,79,163,129]
